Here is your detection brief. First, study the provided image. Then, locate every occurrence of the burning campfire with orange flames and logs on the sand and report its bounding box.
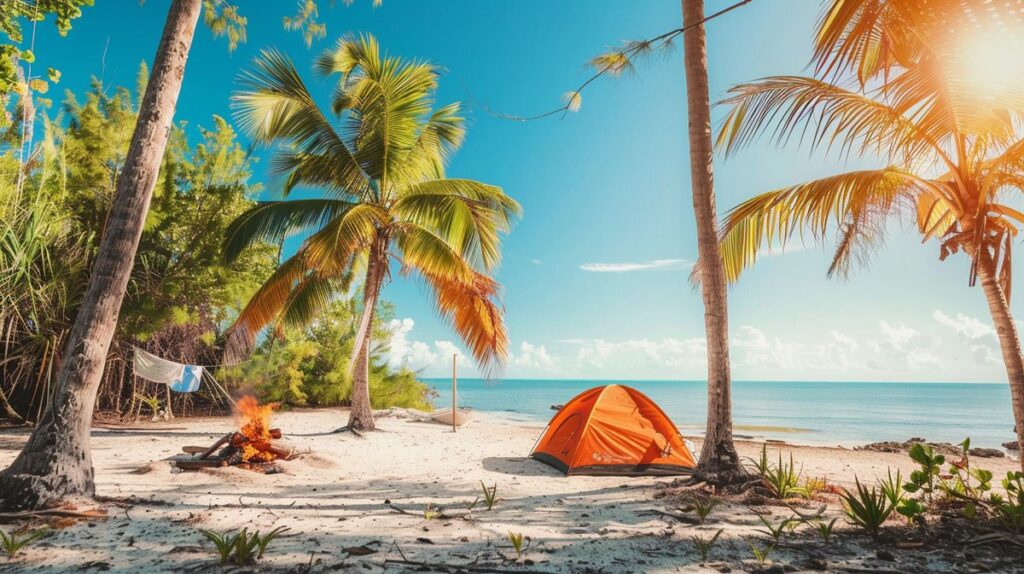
[175,396,295,473]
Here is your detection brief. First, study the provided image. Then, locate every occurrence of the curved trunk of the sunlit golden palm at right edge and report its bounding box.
[978,253,1024,471]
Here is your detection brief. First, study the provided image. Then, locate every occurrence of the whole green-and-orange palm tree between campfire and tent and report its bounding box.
[224,35,520,429]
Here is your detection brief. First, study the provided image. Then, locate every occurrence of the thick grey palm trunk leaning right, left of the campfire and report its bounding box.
[0,0,202,509]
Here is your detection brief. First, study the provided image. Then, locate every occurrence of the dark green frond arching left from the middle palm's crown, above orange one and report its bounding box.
[223,200,356,263]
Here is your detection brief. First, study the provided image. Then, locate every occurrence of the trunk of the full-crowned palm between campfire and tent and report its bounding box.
[348,236,387,431]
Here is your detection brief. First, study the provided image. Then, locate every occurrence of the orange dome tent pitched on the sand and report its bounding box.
[530,385,696,476]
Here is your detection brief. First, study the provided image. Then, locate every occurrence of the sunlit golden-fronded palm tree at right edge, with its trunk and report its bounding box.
[717,5,1024,468]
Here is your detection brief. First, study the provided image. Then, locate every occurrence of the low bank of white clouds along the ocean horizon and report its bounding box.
[387,313,1005,382]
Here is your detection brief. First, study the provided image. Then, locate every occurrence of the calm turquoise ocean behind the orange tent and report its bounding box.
[425,379,1015,447]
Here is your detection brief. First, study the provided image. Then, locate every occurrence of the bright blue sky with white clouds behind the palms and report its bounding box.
[28,0,1020,382]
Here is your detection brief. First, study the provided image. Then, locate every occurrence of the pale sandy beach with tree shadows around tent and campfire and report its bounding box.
[0,409,1016,572]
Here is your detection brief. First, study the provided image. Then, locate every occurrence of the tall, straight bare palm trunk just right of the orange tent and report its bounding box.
[682,0,741,484]
